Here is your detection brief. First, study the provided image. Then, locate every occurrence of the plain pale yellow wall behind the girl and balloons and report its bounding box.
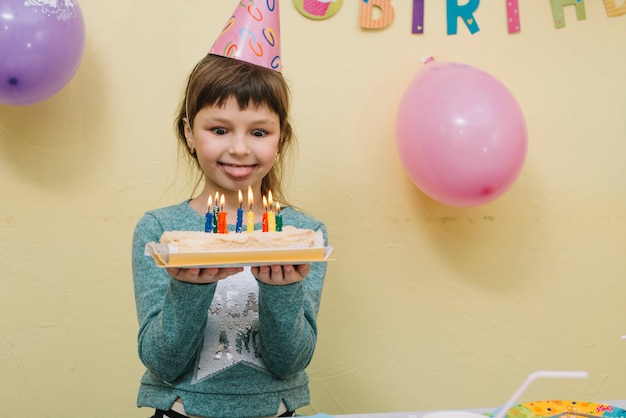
[0,0,626,417]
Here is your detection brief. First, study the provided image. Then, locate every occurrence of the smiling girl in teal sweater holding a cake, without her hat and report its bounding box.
[133,54,327,418]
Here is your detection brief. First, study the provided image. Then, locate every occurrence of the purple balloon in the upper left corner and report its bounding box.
[0,0,85,105]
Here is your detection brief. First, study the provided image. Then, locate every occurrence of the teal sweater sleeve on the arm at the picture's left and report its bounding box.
[133,214,216,382]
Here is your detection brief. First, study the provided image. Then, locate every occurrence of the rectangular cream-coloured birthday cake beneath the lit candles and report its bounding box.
[160,226,324,252]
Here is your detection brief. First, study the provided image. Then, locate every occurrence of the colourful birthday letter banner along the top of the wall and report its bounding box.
[293,0,626,35]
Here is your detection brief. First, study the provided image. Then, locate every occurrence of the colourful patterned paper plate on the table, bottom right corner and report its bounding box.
[492,400,626,418]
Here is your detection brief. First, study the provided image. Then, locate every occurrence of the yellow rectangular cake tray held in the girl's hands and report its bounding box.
[145,242,332,268]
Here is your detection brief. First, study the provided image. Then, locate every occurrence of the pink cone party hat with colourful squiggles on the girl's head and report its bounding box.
[209,0,282,72]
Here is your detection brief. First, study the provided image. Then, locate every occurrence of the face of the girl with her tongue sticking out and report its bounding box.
[185,98,280,196]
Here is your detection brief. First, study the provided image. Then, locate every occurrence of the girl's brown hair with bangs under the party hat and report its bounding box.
[175,54,296,202]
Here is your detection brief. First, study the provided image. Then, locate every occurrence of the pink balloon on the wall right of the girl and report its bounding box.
[396,60,527,207]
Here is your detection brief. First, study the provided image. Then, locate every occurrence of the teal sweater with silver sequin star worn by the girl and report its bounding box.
[132,201,327,418]
